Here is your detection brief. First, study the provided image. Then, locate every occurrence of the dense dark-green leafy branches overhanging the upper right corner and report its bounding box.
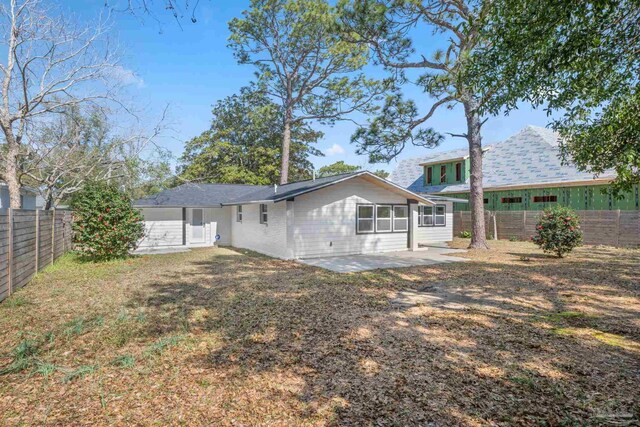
[468,0,640,195]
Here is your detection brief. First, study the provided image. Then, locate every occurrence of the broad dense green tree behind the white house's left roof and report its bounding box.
[179,88,323,185]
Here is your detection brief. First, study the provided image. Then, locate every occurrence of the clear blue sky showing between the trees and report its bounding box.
[71,0,549,175]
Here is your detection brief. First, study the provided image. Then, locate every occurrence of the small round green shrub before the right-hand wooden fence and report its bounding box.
[531,206,582,258]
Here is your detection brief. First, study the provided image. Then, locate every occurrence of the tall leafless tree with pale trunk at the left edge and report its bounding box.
[0,0,122,208]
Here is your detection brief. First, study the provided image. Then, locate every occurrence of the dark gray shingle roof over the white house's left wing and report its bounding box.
[134,183,272,207]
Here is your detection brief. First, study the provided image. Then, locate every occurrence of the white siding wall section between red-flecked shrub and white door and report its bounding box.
[140,208,182,247]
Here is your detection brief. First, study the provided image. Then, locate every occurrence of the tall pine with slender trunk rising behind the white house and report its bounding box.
[229,0,382,184]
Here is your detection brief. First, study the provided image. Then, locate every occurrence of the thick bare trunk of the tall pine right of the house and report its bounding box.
[463,100,489,249]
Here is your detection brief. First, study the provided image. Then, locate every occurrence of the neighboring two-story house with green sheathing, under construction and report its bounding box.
[389,126,640,211]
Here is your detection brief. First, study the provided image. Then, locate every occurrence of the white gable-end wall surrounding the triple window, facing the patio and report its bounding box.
[293,178,407,258]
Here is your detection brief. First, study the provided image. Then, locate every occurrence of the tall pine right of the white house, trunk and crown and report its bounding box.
[339,0,487,249]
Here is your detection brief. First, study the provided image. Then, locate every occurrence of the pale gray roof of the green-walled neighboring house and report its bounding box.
[389,126,615,193]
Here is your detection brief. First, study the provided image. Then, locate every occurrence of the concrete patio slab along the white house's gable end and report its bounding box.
[297,244,468,273]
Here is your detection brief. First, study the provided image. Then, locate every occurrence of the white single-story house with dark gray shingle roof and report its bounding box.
[134,171,460,259]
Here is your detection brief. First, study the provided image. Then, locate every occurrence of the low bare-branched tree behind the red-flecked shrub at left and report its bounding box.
[21,106,166,209]
